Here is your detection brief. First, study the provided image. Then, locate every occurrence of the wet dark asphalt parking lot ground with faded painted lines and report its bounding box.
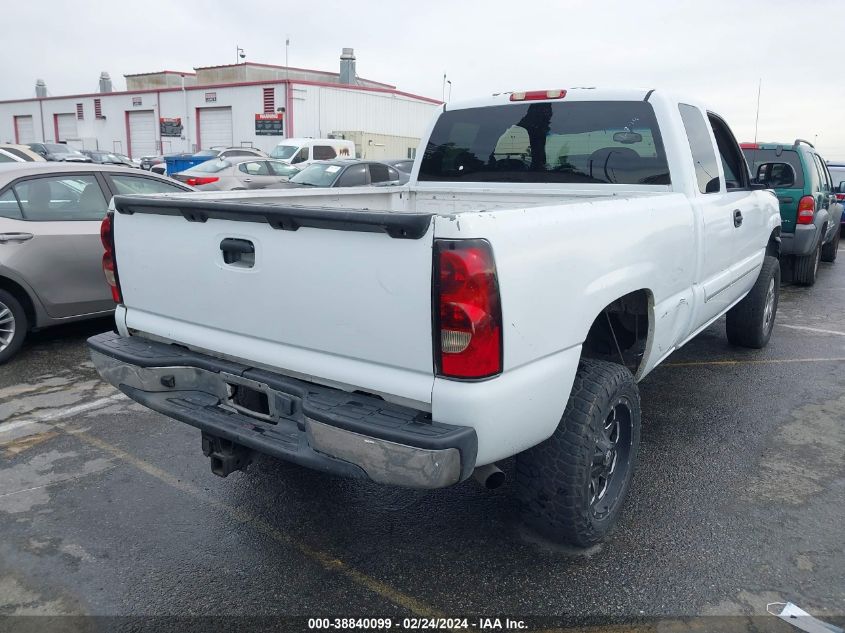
[0,248,845,628]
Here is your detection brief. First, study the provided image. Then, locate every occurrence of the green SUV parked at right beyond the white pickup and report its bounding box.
[741,139,842,286]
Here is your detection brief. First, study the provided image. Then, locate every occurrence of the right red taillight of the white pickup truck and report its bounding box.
[434,240,502,378]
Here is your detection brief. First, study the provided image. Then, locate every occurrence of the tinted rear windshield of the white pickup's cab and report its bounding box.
[420,101,669,185]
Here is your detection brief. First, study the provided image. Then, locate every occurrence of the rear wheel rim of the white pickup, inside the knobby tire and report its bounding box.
[588,398,633,519]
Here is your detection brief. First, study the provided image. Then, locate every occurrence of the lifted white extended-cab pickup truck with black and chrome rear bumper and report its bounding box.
[89,89,780,546]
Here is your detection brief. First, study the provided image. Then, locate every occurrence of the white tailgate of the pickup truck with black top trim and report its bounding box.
[114,196,433,403]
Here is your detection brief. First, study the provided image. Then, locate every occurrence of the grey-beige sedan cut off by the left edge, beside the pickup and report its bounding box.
[0,161,190,364]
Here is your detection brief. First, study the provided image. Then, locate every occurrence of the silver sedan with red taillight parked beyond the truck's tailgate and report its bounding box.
[173,157,299,191]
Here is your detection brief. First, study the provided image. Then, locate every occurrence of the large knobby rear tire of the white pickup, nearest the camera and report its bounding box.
[516,359,641,547]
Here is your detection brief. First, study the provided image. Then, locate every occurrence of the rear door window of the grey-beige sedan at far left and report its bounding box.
[14,175,108,222]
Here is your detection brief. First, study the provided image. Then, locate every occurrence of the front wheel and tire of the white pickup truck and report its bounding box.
[726,256,780,349]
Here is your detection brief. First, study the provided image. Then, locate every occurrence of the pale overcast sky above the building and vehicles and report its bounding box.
[6,0,845,160]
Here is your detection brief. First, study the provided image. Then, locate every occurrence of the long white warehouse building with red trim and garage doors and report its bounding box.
[0,49,440,159]
